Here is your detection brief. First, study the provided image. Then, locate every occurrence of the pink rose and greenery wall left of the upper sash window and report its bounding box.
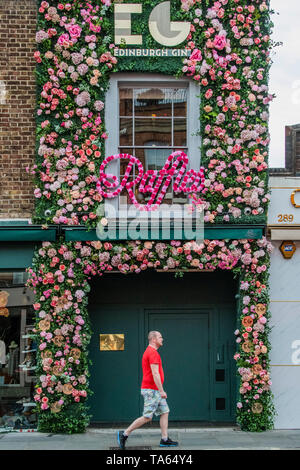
[27,0,117,225]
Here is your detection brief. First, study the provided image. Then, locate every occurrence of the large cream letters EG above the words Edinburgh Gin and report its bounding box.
[115,2,190,46]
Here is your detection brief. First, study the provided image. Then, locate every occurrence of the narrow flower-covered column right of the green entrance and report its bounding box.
[234,240,275,431]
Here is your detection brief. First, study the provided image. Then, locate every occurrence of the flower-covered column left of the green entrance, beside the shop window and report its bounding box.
[29,242,91,433]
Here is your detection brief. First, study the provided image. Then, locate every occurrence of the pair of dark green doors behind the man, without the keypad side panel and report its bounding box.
[90,305,210,422]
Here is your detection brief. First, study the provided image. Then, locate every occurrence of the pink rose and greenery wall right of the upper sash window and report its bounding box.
[182,0,273,222]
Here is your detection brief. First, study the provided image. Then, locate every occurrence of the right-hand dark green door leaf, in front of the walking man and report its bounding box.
[148,310,209,421]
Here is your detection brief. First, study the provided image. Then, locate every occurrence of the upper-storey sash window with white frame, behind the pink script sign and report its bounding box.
[105,74,200,215]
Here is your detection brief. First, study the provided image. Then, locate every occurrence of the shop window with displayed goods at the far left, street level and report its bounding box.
[0,273,37,431]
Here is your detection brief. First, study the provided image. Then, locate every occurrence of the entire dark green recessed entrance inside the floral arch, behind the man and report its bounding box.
[89,271,237,423]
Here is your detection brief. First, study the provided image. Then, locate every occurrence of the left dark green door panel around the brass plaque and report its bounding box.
[89,304,140,422]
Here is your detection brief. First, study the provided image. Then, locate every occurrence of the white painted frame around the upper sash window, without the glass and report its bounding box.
[105,73,201,219]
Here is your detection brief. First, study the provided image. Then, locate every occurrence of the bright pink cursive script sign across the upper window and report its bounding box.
[97,151,205,211]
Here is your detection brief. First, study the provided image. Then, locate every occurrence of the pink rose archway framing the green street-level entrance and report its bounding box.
[28,238,274,433]
